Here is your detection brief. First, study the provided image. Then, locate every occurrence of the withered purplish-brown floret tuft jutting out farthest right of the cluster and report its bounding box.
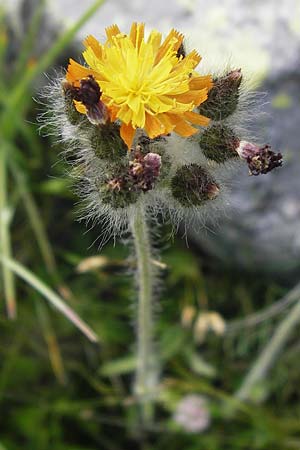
[236,141,282,176]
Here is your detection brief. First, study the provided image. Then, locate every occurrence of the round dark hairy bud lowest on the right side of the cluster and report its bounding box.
[171,164,220,207]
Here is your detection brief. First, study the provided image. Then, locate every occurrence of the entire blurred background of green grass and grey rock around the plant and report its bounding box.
[0,0,300,450]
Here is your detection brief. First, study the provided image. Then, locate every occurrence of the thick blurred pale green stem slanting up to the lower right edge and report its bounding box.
[236,294,300,400]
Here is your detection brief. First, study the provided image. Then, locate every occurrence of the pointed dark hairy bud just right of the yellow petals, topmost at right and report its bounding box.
[199,69,242,121]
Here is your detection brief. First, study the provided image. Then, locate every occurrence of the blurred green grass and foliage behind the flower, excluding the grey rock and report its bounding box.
[0,0,300,450]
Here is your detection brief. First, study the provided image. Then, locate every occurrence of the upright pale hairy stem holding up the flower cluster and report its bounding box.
[131,205,158,424]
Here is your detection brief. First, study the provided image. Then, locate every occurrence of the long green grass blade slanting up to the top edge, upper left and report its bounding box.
[1,0,105,137]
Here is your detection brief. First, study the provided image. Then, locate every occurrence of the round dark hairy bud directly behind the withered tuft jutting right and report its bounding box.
[199,123,240,163]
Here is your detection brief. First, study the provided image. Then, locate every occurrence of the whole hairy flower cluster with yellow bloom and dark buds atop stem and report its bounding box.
[44,23,282,239]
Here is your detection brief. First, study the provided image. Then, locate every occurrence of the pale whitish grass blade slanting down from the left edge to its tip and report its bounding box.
[0,255,98,342]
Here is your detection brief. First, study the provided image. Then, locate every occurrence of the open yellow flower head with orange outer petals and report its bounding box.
[66,23,212,148]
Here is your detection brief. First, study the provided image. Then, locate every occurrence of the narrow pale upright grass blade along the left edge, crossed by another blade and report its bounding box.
[0,145,17,319]
